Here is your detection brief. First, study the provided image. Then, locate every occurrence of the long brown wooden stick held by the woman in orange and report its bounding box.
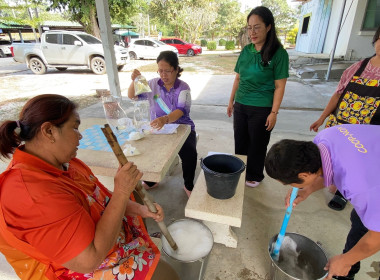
[102,124,178,250]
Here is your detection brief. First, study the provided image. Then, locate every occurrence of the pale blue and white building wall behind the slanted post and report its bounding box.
[296,0,375,60]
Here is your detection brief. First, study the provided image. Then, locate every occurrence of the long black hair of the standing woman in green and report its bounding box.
[247,6,282,66]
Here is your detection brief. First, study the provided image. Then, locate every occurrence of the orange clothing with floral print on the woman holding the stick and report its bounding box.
[0,149,159,279]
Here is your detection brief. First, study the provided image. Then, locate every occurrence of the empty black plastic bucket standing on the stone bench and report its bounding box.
[201,154,245,199]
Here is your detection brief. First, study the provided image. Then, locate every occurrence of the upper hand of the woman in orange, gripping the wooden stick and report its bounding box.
[114,162,143,197]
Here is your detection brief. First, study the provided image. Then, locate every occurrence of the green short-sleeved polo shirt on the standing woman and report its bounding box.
[235,43,289,107]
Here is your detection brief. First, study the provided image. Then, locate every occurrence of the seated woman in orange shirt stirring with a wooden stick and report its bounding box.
[0,94,177,280]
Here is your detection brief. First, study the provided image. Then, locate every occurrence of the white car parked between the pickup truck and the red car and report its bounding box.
[128,38,178,59]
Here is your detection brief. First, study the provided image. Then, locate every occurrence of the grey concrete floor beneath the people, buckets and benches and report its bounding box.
[0,72,380,280]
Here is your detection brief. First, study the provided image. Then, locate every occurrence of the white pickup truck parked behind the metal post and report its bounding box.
[12,30,129,74]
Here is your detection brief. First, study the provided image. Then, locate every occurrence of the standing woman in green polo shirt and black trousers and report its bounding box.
[227,6,289,187]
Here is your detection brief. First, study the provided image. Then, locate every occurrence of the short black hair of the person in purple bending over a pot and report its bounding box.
[265,139,322,185]
